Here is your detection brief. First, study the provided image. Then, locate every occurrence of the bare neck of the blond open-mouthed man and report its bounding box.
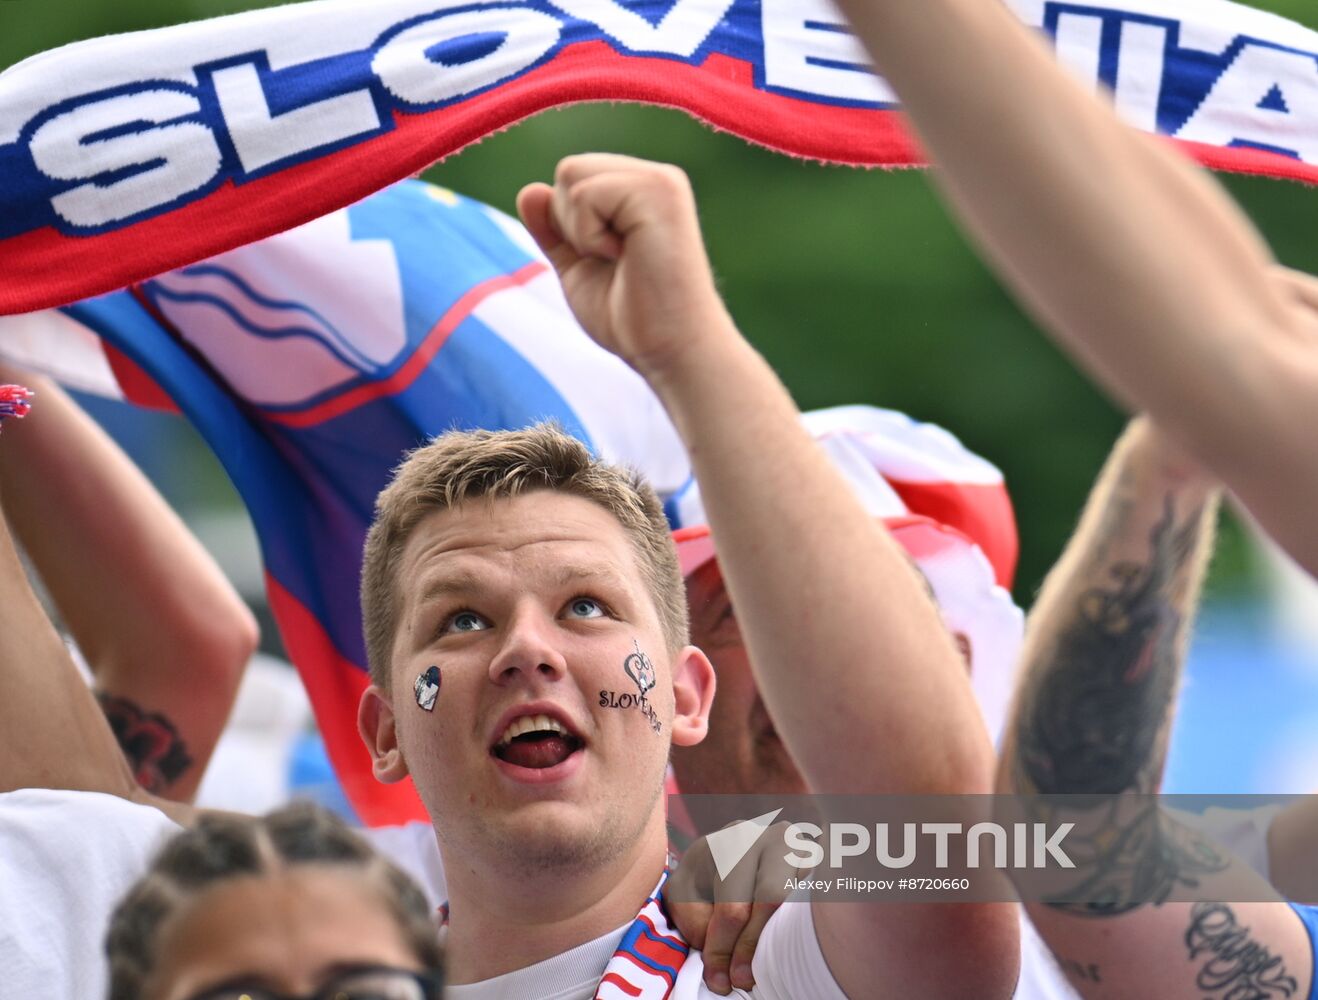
[440,808,668,986]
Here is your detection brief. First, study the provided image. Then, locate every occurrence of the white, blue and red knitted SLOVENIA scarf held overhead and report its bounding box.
[0,0,1318,314]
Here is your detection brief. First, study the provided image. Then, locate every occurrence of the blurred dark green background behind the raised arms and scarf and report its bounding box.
[0,0,1318,605]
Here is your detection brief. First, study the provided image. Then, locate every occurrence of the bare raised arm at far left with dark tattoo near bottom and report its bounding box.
[0,368,257,801]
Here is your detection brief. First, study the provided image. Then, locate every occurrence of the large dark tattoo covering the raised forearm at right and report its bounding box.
[1014,497,1228,917]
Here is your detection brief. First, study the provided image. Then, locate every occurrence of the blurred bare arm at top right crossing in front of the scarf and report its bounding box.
[840,0,1318,572]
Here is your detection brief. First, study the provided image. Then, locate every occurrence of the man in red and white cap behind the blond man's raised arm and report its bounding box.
[666,406,1023,794]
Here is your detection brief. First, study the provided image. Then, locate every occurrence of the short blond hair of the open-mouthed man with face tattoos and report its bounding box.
[361,424,688,690]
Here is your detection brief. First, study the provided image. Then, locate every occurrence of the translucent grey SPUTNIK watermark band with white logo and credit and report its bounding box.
[670,794,1318,909]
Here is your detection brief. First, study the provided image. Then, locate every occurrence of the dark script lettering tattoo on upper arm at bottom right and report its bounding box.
[1185,903,1298,1000]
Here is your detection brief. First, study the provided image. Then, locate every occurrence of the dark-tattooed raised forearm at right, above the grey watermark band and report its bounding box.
[1007,420,1218,811]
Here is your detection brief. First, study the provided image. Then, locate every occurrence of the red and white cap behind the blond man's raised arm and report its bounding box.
[666,406,1024,736]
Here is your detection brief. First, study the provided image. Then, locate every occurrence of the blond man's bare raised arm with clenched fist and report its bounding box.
[519,155,1016,997]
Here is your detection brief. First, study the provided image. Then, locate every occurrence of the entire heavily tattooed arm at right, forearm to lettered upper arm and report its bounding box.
[999,420,1313,1000]
